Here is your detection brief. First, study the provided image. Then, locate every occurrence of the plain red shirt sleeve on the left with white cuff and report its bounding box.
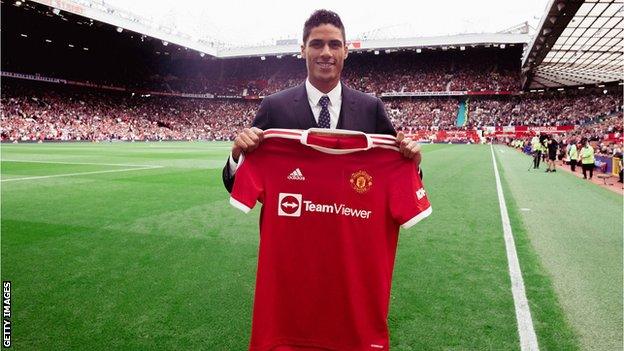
[230,153,264,213]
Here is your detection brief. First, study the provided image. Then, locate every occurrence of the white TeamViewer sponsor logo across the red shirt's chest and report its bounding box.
[277,193,373,219]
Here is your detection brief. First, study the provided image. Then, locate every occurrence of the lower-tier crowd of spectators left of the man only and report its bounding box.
[0,85,258,141]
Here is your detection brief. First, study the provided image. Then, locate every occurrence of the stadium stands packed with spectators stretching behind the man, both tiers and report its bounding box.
[1,2,622,147]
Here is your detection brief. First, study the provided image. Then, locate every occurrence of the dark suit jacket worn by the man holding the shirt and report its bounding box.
[223,83,396,192]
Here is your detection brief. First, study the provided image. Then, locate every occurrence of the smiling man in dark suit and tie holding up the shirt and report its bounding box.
[223,10,422,192]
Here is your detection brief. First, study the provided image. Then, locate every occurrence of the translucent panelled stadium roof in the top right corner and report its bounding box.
[522,0,624,89]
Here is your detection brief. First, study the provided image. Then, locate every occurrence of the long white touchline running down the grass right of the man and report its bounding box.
[490,145,539,351]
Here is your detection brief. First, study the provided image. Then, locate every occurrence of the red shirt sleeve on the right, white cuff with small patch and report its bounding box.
[390,162,431,229]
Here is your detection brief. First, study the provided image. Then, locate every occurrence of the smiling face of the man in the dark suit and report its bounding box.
[301,24,348,93]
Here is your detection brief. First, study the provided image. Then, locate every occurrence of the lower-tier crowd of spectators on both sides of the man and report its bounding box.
[0,79,622,141]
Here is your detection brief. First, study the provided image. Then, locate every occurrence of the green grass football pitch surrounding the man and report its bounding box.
[1,142,623,350]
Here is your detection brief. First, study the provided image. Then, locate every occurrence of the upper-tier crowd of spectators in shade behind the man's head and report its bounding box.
[133,48,520,96]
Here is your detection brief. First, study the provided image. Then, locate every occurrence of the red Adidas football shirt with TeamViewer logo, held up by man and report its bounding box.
[230,129,431,351]
